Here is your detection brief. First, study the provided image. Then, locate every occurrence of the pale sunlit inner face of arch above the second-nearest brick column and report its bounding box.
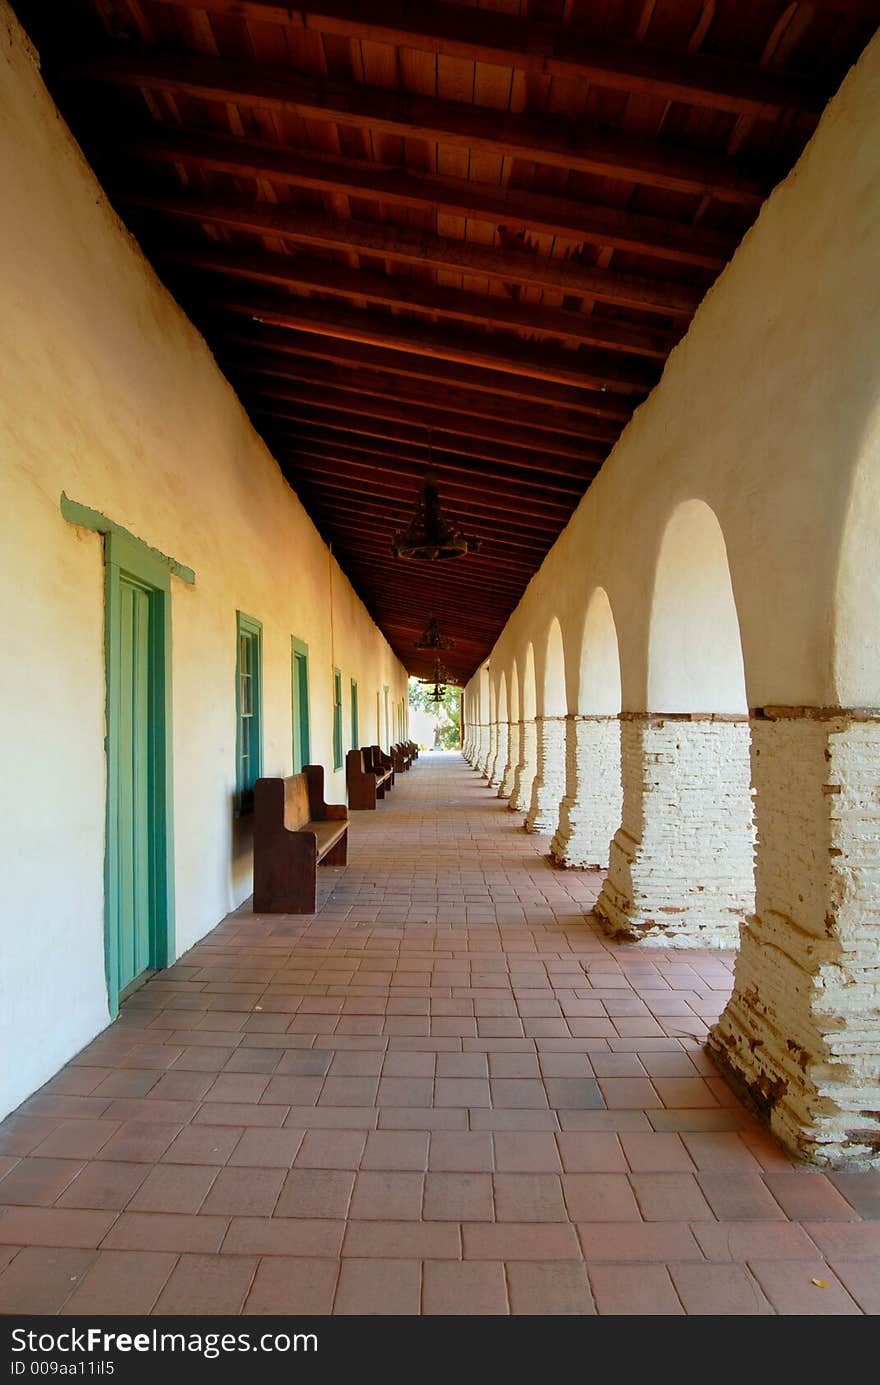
[647,500,747,716]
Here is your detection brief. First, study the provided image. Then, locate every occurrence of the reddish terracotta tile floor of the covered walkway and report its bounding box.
[0,755,880,1314]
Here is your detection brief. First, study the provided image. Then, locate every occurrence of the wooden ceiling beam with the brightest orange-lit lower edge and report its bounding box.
[200,293,658,396]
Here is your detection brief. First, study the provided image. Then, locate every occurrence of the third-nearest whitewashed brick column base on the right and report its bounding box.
[550,716,624,870]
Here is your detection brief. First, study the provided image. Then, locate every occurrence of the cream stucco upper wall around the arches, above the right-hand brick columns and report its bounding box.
[471,31,880,712]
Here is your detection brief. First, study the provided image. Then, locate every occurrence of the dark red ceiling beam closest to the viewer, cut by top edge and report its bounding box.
[149,0,830,123]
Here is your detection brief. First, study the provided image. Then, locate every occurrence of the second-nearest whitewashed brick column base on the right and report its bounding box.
[596,712,754,947]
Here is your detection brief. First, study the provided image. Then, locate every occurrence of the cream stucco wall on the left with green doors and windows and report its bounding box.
[0,8,406,1111]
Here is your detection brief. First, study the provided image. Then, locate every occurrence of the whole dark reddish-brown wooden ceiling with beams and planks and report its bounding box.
[12,0,880,680]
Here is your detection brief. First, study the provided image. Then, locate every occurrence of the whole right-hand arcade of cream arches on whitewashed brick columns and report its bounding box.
[464,35,880,1165]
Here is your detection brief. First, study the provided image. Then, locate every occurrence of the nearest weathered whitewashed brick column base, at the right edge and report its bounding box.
[708,708,880,1166]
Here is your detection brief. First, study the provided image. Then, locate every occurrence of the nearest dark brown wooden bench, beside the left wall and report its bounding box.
[254,765,348,914]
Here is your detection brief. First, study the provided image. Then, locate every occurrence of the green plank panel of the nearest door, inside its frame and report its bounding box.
[111,575,157,992]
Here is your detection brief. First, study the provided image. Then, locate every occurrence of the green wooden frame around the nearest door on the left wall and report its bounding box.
[104,529,175,1018]
